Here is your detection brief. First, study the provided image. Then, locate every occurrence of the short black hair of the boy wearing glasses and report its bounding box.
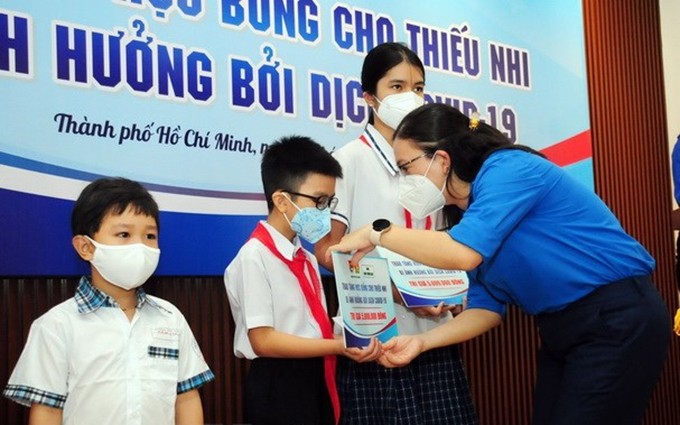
[261,136,342,211]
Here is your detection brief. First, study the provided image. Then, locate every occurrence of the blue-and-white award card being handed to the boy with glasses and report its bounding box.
[333,252,398,347]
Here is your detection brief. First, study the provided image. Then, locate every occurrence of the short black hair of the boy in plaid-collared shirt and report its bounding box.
[71,177,160,237]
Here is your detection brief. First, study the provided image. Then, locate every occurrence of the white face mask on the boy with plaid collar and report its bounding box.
[85,236,161,290]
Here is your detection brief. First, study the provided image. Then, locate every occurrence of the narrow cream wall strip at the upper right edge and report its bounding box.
[659,0,680,205]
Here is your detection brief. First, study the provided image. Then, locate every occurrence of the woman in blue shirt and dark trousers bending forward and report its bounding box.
[330,104,670,425]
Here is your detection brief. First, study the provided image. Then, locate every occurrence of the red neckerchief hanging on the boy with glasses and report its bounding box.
[250,223,340,424]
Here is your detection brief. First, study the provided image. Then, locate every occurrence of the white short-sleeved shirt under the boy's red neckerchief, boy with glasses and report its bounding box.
[224,221,326,359]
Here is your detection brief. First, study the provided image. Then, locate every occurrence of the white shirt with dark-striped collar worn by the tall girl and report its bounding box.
[331,124,451,335]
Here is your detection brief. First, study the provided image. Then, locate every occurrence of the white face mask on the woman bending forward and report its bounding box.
[399,156,446,220]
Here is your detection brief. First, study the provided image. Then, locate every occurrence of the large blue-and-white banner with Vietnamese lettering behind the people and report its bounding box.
[0,0,593,276]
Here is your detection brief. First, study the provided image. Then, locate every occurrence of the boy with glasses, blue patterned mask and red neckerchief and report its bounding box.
[224,136,380,425]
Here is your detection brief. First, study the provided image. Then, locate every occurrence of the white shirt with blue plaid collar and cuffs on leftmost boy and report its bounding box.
[4,277,215,425]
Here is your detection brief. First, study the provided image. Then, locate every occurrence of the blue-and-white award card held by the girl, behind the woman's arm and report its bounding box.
[375,246,469,307]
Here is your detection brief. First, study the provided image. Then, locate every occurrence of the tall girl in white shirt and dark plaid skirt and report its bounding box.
[315,43,477,425]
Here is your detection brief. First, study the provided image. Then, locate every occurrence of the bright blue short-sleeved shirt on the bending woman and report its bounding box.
[449,149,655,315]
